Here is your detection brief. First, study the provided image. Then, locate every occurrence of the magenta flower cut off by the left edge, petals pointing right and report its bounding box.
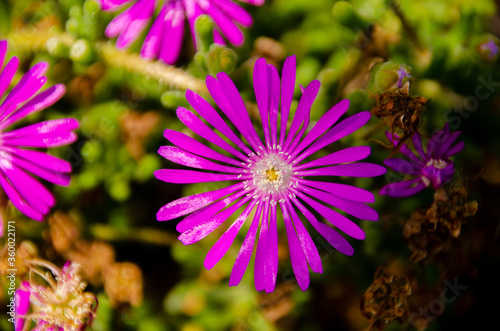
[0,40,78,221]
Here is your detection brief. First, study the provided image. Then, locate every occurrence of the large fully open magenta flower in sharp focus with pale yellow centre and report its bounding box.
[155,57,386,292]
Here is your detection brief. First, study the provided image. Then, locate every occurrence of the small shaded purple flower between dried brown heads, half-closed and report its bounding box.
[380,123,465,197]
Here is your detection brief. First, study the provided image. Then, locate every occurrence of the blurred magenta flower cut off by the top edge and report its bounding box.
[101,0,264,64]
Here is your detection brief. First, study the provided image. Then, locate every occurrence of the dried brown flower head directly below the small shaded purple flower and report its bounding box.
[404,187,478,262]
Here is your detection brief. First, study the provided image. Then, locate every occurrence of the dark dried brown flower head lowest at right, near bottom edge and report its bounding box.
[360,267,411,330]
